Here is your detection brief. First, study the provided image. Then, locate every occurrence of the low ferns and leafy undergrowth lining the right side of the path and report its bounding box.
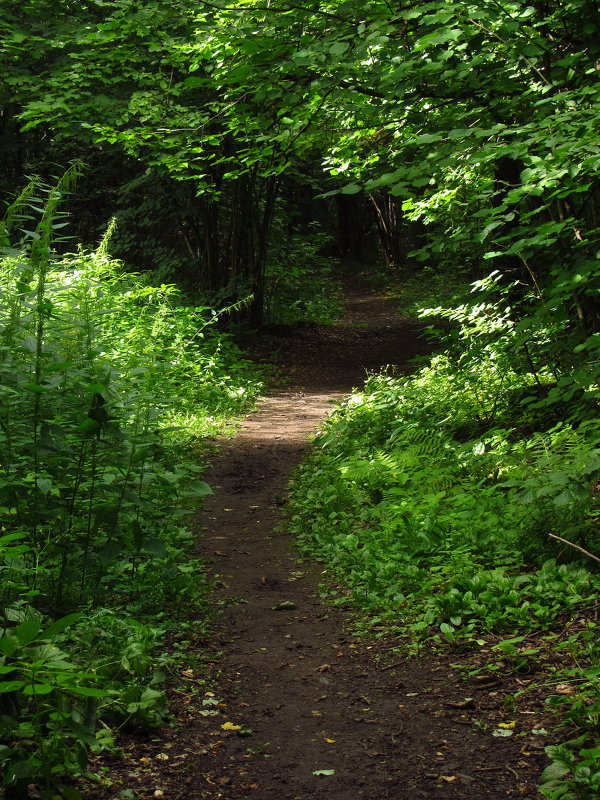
[289,278,600,798]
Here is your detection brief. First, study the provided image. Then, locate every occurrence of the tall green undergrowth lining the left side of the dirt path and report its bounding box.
[0,178,261,798]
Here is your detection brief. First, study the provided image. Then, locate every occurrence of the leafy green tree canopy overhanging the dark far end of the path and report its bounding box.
[0,0,600,326]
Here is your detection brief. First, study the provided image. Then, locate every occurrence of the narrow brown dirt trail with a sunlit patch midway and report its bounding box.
[89,278,539,800]
